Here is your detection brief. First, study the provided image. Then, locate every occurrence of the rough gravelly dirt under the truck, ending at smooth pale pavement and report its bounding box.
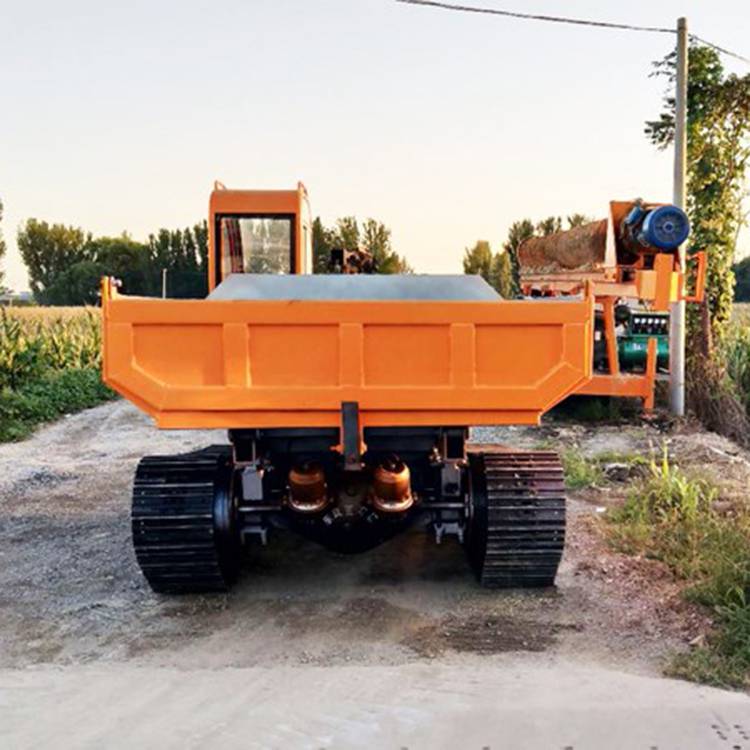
[0,401,720,675]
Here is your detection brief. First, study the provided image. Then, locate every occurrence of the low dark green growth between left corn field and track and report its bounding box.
[0,368,116,442]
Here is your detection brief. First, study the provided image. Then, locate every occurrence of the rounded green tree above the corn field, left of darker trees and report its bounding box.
[18,219,92,304]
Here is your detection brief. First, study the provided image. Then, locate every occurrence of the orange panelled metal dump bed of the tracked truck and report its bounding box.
[102,281,593,428]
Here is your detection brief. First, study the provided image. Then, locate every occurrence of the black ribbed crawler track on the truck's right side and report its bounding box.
[466,452,565,588]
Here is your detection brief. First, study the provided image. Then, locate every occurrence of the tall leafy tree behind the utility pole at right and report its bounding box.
[646,44,750,350]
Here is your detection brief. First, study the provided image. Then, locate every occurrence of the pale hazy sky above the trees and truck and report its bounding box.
[0,0,750,289]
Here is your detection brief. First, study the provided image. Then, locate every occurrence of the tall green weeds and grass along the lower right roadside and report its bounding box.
[607,454,750,687]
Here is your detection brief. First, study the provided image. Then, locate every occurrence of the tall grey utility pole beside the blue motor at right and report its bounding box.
[669,18,688,417]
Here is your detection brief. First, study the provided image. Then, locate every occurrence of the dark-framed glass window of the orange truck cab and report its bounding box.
[219,216,294,278]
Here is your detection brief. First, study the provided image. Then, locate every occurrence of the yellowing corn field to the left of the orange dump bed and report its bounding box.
[0,307,101,390]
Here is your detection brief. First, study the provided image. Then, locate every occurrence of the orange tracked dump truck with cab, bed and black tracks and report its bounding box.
[102,184,704,593]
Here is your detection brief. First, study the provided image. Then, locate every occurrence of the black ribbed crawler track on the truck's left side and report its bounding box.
[131,446,241,593]
